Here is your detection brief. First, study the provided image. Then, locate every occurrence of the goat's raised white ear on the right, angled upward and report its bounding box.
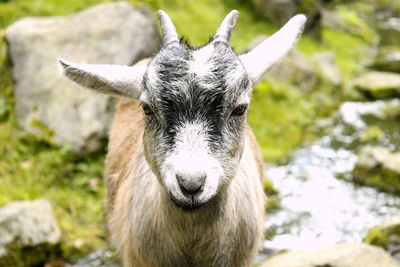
[239,14,306,85]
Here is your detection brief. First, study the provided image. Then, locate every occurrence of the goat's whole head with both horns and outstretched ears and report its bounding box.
[59,10,305,209]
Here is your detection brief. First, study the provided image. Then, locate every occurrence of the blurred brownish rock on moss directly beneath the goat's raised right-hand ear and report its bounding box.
[267,49,318,91]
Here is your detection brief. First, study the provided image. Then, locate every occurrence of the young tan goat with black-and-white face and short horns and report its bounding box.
[59,10,306,267]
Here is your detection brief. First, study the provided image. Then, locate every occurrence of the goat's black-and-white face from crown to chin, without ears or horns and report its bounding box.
[140,42,251,208]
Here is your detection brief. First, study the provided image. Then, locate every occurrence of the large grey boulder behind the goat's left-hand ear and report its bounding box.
[5,2,161,154]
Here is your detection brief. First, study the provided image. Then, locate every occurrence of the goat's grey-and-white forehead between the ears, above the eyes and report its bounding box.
[145,43,249,100]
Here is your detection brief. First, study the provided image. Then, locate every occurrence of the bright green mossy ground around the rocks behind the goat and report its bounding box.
[0,0,368,264]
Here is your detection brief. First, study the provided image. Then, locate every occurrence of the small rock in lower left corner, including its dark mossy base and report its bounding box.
[0,199,61,266]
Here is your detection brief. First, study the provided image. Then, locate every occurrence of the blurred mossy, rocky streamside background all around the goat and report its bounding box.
[0,0,400,267]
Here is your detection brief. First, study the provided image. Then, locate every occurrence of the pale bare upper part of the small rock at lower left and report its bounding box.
[0,199,61,265]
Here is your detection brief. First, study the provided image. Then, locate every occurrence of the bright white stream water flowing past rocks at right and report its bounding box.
[264,99,400,260]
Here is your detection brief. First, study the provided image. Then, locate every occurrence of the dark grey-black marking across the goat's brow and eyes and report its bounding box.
[143,42,249,156]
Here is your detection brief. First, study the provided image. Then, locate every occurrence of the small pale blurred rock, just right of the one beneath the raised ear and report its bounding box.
[312,52,342,86]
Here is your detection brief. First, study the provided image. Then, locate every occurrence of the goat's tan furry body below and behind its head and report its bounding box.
[106,100,264,266]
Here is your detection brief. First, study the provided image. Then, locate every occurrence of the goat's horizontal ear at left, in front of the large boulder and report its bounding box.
[58,58,147,99]
